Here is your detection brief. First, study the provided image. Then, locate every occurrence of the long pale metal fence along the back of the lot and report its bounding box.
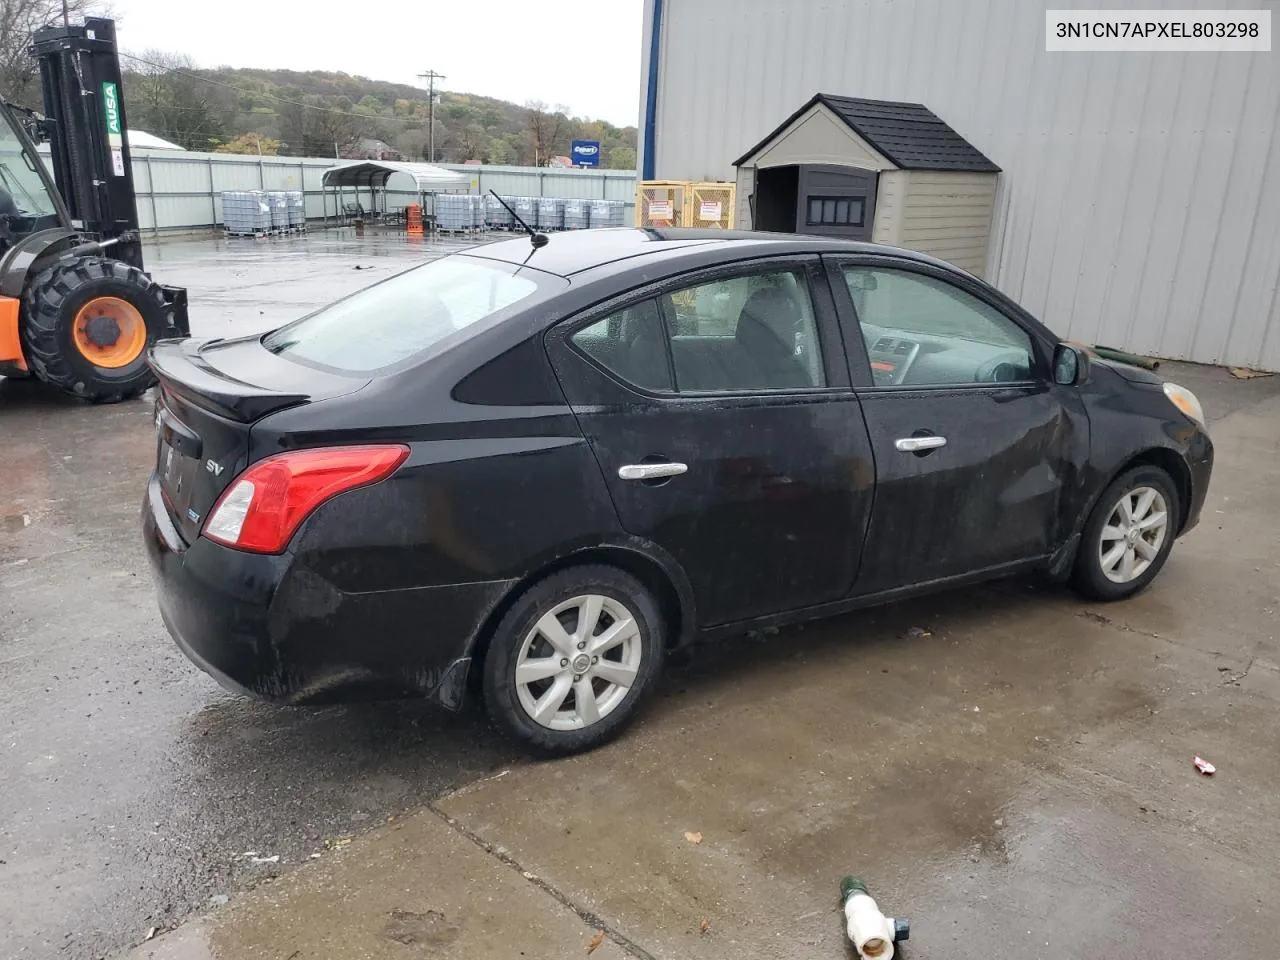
[42,150,636,233]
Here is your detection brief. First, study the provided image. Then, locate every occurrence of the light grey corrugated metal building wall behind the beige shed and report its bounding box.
[641,0,1280,370]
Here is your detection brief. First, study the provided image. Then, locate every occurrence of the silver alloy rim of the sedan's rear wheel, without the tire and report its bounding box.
[515,594,644,730]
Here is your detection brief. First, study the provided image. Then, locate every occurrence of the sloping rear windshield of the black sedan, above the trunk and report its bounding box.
[262,256,554,374]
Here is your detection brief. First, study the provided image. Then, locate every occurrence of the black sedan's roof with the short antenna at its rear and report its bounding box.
[465,227,937,276]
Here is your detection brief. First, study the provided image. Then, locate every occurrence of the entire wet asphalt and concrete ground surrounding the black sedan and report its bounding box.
[0,229,1280,957]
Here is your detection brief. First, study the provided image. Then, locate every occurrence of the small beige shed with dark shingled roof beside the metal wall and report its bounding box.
[733,93,1000,276]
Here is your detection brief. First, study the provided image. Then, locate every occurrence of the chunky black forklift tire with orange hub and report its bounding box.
[22,257,170,403]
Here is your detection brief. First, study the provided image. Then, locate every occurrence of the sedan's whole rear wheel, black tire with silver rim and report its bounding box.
[483,566,667,755]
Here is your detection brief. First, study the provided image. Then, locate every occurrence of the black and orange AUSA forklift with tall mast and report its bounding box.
[0,17,191,403]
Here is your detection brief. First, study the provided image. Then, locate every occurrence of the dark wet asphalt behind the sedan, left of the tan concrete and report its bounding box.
[0,237,508,960]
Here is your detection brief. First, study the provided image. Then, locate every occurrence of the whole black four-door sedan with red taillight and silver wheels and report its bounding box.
[142,229,1213,751]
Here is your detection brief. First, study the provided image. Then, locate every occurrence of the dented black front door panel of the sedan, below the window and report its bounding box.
[856,384,1088,594]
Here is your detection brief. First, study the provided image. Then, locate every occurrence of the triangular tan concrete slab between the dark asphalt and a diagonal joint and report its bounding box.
[128,812,626,960]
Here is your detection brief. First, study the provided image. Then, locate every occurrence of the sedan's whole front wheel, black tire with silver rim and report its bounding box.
[1071,466,1181,602]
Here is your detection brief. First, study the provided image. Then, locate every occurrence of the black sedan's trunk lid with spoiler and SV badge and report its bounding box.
[150,338,369,544]
